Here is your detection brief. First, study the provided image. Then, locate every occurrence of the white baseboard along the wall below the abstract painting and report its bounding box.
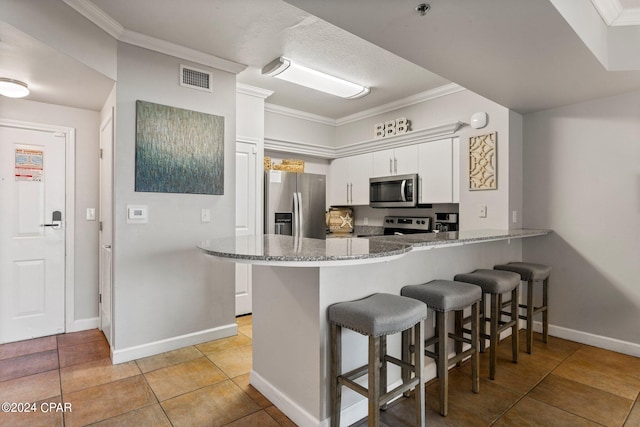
[111,322,238,364]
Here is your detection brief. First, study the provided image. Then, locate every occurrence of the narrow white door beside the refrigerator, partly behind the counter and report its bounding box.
[236,141,258,316]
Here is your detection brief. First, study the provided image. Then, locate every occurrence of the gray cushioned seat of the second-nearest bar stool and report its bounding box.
[401,280,482,312]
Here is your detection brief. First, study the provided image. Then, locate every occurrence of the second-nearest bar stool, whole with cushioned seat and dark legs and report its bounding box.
[400,280,482,417]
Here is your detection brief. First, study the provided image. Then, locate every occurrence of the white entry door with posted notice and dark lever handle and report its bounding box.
[0,126,66,343]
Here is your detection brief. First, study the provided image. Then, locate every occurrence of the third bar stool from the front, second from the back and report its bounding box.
[453,269,520,380]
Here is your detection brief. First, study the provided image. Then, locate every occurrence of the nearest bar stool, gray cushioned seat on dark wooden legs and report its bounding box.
[328,294,427,427]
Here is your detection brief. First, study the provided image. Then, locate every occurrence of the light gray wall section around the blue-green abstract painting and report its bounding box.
[113,43,236,361]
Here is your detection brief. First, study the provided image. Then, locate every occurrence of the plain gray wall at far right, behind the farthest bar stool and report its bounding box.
[523,88,640,356]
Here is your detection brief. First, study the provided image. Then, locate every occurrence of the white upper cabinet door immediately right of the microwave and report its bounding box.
[418,138,453,203]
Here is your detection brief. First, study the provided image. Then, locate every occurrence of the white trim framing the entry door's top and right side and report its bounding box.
[0,118,76,338]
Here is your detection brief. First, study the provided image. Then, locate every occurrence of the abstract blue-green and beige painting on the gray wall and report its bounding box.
[135,101,224,195]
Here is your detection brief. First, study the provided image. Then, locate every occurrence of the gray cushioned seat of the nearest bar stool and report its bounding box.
[329,294,427,337]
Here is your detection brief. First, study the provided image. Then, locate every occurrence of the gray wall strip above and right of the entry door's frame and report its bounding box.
[0,96,100,322]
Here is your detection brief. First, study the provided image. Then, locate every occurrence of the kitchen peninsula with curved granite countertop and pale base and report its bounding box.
[199,229,549,426]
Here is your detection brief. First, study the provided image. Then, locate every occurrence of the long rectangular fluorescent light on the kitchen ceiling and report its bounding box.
[262,56,369,99]
